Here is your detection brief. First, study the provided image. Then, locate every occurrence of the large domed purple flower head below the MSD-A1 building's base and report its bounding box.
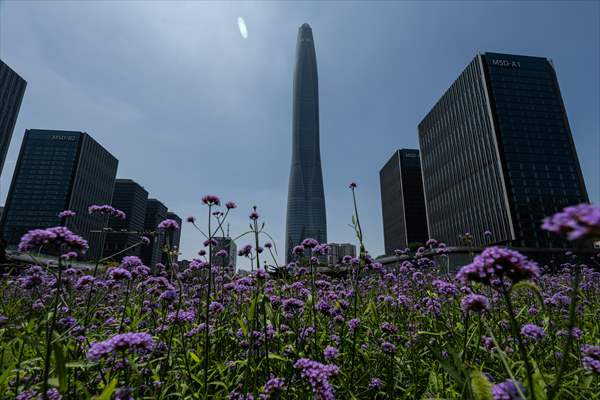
[456,247,540,285]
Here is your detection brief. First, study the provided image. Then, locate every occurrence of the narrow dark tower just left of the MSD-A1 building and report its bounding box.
[379,149,428,254]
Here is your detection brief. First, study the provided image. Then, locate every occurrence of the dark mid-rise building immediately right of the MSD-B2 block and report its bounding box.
[103,179,148,261]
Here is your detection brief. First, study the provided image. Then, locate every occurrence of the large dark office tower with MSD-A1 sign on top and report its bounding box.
[419,53,588,247]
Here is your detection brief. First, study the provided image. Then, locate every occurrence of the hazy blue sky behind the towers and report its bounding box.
[0,1,600,268]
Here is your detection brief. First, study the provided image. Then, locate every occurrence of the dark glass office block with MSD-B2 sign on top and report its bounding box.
[0,129,118,258]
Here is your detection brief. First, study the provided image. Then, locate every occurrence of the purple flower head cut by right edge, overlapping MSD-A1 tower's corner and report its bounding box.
[542,203,600,240]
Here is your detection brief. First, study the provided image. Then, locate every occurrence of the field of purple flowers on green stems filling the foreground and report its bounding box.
[0,192,600,400]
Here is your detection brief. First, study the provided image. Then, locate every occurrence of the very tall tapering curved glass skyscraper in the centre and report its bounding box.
[285,24,327,262]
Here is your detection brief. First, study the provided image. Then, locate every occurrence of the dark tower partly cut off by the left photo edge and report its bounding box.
[0,60,27,178]
